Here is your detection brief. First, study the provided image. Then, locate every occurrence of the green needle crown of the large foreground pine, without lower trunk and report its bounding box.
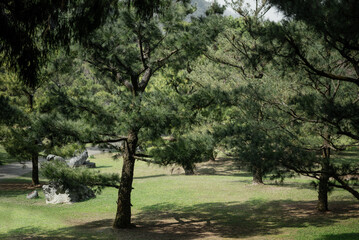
[76,1,225,150]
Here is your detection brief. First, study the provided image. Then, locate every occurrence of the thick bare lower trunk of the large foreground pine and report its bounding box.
[113,130,138,228]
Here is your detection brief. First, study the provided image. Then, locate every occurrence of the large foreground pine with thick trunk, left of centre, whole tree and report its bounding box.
[81,1,222,228]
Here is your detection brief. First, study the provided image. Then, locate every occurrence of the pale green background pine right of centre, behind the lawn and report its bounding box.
[198,1,288,184]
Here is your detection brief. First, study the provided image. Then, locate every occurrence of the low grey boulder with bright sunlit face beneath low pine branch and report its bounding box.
[42,183,95,204]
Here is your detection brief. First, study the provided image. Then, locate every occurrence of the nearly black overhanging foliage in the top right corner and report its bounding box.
[269,0,359,46]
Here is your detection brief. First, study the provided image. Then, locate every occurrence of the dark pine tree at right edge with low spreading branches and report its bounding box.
[255,17,359,211]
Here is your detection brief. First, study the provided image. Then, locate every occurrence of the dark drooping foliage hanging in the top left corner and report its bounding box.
[0,0,116,87]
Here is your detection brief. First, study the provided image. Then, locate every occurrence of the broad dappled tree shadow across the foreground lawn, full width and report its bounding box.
[0,200,359,240]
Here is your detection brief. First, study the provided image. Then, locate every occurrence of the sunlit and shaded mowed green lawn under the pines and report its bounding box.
[0,154,359,240]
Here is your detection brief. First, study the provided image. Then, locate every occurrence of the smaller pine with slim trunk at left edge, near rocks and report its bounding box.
[0,52,90,185]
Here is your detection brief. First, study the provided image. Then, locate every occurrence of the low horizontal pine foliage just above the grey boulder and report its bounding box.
[41,161,120,193]
